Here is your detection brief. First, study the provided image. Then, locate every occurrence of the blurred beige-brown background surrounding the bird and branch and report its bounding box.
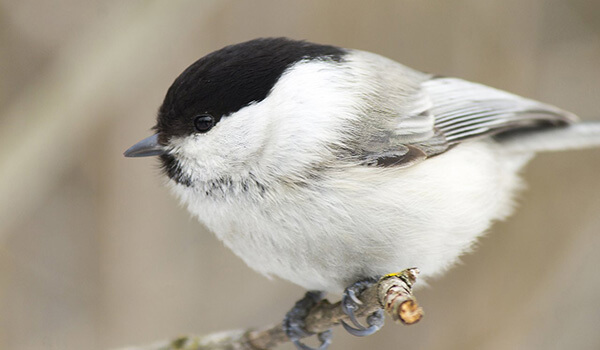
[0,0,600,350]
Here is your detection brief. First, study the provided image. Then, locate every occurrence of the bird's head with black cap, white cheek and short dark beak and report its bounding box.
[125,38,351,187]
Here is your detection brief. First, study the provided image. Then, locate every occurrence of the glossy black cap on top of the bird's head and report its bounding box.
[155,38,346,143]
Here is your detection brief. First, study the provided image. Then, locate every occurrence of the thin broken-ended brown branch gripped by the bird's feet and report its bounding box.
[122,268,423,350]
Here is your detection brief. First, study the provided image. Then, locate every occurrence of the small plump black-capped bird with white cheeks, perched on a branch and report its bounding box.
[125,38,600,349]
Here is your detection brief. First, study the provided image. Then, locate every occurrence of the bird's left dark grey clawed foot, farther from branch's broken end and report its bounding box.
[283,291,332,350]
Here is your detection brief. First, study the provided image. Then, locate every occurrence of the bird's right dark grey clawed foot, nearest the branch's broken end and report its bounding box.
[342,278,384,337]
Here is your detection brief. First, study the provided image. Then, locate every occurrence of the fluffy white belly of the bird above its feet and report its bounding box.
[175,140,530,292]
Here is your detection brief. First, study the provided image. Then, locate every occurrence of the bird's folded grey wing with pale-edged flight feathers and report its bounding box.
[367,78,577,166]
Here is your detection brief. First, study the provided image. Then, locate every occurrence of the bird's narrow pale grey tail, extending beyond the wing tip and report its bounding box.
[498,121,600,152]
